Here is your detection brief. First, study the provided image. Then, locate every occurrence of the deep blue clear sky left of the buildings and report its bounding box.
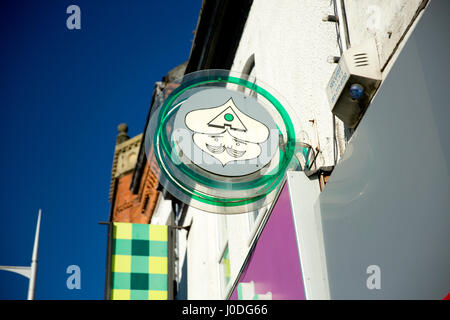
[0,0,201,299]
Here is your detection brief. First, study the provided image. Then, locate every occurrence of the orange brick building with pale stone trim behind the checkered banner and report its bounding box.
[105,64,186,299]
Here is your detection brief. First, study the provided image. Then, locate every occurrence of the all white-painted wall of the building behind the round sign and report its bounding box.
[185,0,421,299]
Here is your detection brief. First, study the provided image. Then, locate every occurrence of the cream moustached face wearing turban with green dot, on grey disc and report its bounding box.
[185,98,269,166]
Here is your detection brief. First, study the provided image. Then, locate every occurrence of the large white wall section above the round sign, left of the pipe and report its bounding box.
[232,0,339,169]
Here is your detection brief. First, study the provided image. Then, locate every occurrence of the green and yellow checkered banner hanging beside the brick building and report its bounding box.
[111,222,168,300]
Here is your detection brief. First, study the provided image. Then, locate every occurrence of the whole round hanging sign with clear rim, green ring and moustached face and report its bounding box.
[145,70,299,214]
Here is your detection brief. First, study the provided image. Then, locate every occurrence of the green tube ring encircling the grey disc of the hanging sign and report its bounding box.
[154,76,295,206]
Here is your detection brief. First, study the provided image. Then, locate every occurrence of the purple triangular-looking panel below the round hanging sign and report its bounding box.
[230,183,305,300]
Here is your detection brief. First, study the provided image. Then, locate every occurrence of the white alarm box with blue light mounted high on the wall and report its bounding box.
[326,40,381,128]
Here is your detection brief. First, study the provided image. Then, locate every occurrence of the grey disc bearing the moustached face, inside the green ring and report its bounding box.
[172,88,279,177]
